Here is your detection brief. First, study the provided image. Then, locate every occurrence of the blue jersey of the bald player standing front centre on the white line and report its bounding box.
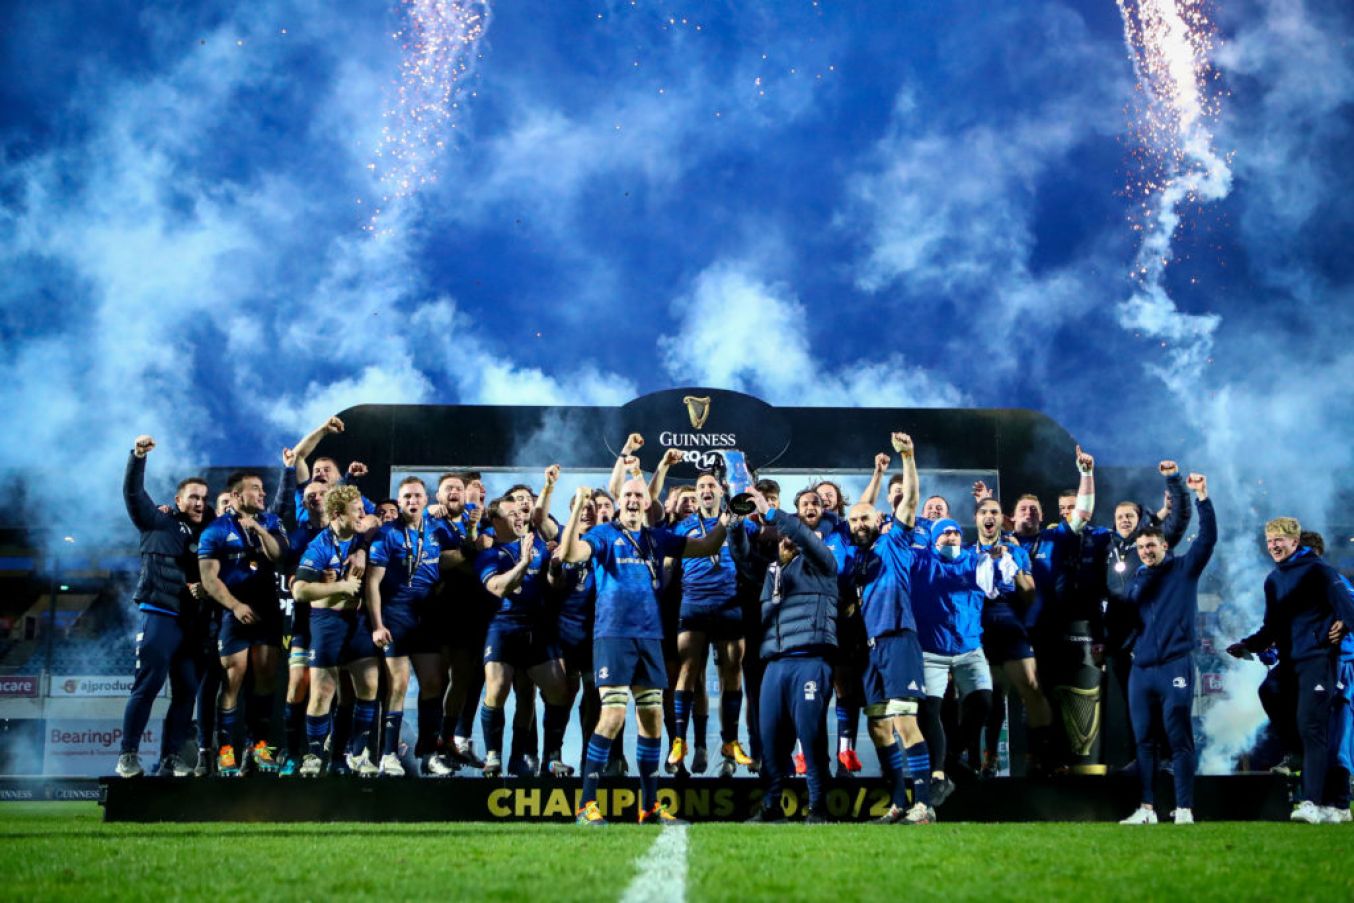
[581,521,686,639]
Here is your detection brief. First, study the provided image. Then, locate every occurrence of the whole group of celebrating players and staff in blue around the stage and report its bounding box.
[116,417,1354,824]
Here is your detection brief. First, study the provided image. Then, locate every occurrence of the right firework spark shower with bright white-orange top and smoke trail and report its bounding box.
[1117,0,1232,389]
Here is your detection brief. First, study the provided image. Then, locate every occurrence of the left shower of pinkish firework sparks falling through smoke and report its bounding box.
[359,0,490,232]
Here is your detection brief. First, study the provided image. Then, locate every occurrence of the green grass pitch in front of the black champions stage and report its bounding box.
[0,803,1354,903]
